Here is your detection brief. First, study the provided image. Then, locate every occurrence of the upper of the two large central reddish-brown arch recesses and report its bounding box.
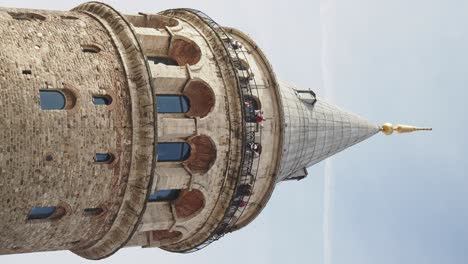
[183,79,216,117]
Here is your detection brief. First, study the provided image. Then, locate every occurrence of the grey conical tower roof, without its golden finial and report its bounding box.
[277,83,380,181]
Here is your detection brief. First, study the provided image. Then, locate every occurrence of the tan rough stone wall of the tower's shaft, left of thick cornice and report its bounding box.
[0,9,132,254]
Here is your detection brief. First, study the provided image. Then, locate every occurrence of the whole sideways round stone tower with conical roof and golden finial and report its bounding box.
[0,2,432,259]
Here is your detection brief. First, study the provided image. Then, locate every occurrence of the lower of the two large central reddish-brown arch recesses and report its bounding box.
[184,135,217,173]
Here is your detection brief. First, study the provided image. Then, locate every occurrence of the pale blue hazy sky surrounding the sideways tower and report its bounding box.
[0,0,468,264]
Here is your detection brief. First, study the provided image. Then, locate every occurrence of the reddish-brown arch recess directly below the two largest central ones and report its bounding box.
[173,189,205,219]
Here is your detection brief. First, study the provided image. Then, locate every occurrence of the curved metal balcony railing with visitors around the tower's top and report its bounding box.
[167,9,265,253]
